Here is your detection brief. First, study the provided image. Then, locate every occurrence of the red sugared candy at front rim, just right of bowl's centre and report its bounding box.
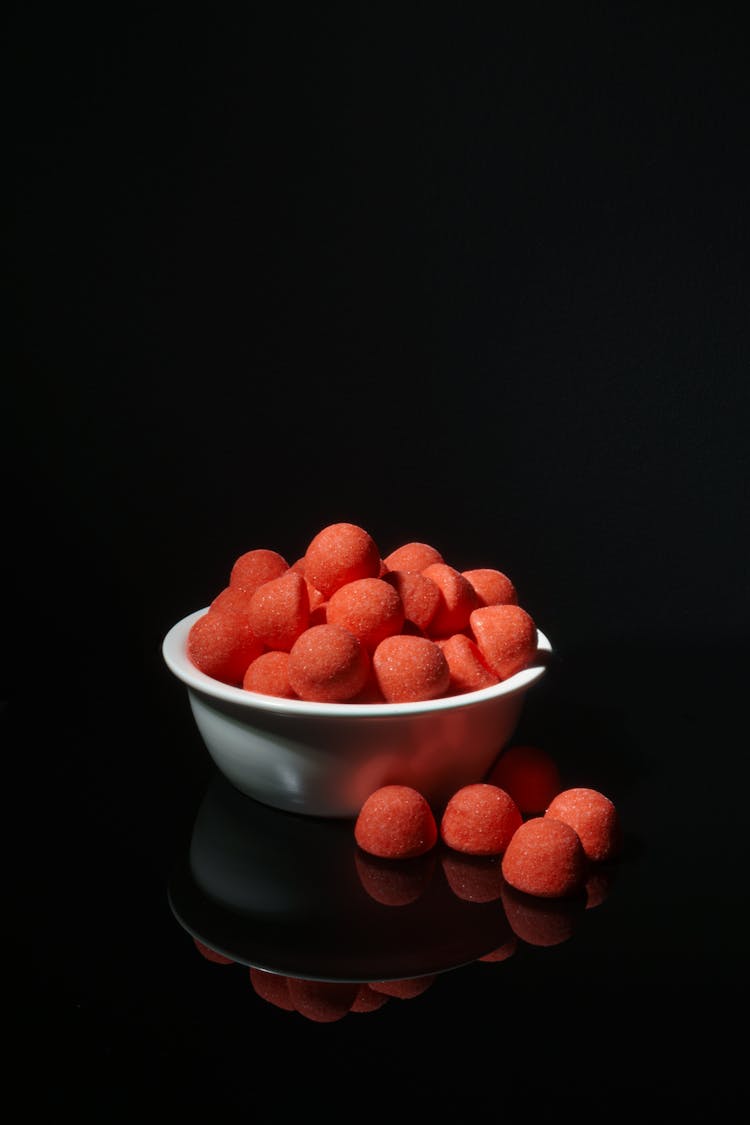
[372,633,451,703]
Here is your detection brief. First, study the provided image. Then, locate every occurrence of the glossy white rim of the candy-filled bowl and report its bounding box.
[162,606,553,719]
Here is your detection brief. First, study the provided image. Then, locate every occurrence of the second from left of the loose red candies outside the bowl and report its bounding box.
[440,782,523,855]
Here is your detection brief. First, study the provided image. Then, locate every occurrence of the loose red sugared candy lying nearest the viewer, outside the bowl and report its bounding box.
[503,816,588,898]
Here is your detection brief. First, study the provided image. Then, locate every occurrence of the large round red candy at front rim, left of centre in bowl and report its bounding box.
[288,624,371,703]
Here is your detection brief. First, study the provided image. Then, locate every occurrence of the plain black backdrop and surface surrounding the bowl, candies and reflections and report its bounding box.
[3,3,750,1122]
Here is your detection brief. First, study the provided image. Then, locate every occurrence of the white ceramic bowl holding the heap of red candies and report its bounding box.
[162,609,552,818]
